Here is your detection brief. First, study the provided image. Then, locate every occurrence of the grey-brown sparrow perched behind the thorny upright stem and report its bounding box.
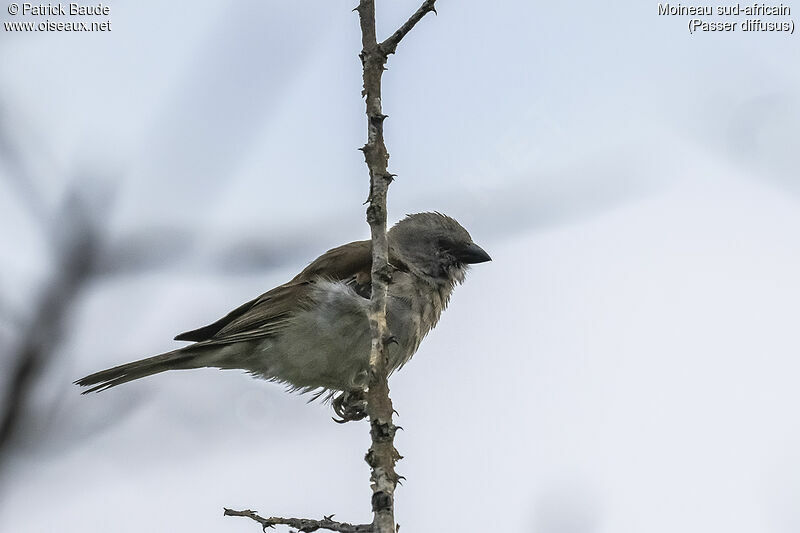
[75,213,491,420]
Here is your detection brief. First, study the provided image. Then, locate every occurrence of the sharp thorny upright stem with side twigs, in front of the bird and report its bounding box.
[225,0,435,533]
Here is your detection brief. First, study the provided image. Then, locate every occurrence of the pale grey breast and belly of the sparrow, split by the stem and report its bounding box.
[251,272,460,390]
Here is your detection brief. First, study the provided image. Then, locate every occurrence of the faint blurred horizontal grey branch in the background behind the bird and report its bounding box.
[97,169,661,278]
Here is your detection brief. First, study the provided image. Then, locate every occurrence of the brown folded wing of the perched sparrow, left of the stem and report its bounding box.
[175,241,372,343]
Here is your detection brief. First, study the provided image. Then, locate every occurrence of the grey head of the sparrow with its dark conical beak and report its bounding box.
[388,213,492,284]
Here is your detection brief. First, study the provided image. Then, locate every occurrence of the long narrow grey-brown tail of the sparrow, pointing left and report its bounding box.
[75,346,210,394]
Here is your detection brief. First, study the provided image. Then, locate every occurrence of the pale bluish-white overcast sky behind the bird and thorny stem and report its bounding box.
[0,0,800,533]
